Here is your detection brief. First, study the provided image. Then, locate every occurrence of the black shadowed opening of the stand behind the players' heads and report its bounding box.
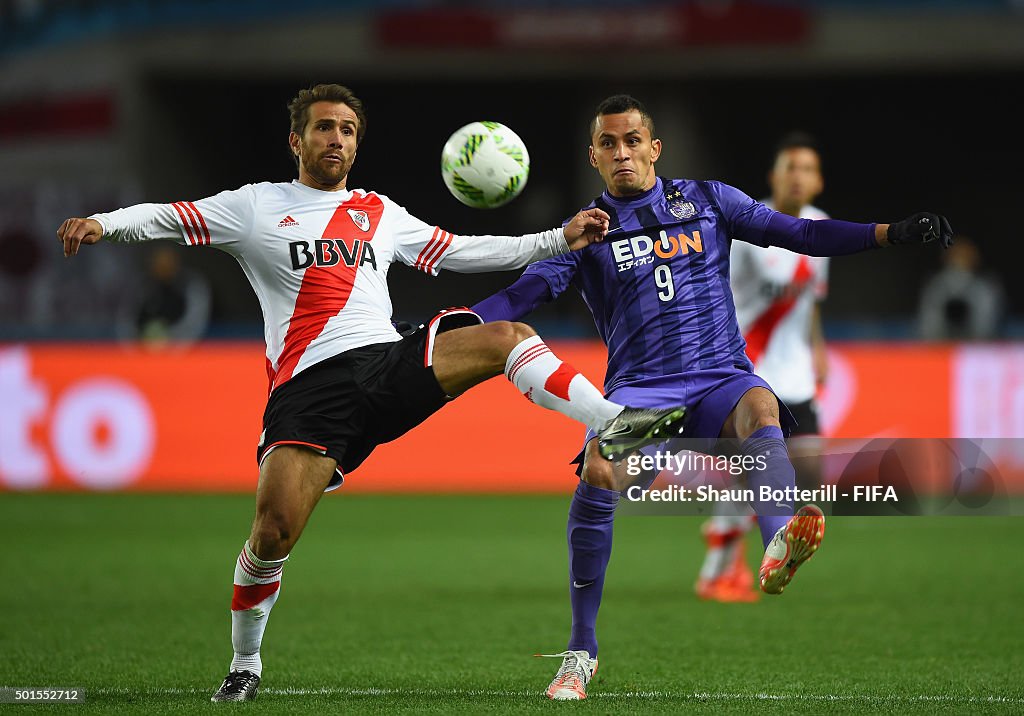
[134,69,1024,335]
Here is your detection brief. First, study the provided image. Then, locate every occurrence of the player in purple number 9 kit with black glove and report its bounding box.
[473,95,952,700]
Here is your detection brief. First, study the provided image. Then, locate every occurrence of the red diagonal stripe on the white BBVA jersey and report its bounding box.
[273,194,384,388]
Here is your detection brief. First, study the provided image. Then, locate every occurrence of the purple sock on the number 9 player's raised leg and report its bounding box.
[742,426,797,547]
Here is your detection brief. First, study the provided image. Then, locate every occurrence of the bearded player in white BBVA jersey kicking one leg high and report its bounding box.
[51,85,684,701]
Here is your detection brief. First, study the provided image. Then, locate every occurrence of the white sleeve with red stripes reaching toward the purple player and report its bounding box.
[388,201,569,276]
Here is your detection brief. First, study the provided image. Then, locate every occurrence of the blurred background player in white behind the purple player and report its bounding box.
[696,132,828,601]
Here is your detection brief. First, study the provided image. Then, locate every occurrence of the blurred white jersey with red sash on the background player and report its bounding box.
[729,201,828,403]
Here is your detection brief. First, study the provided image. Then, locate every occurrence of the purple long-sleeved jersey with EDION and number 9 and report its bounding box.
[473,178,878,428]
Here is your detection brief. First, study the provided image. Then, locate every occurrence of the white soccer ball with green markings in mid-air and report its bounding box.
[441,122,529,209]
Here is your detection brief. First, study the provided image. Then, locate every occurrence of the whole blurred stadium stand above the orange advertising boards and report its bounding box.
[0,0,1024,341]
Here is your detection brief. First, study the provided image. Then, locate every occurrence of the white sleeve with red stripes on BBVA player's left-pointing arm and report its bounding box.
[89,185,254,251]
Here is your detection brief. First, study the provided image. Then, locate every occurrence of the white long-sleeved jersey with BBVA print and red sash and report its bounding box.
[90,180,568,390]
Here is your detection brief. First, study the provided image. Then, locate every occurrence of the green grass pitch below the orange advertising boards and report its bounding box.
[0,491,1024,714]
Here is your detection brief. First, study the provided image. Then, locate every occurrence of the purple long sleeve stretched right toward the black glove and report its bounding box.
[708,181,879,256]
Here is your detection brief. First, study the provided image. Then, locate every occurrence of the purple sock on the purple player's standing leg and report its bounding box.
[566,480,618,658]
